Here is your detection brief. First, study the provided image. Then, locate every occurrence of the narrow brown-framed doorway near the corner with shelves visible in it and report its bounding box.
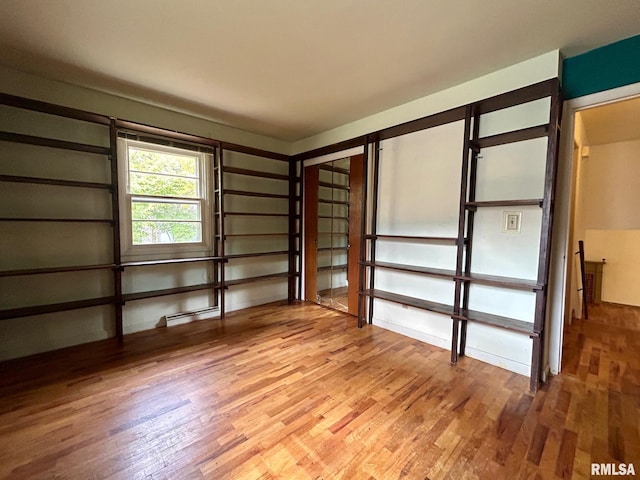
[304,154,364,315]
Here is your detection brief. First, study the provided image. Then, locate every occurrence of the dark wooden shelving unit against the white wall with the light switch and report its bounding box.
[358,79,561,390]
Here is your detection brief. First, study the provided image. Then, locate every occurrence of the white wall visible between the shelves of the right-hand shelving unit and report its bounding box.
[374,100,549,375]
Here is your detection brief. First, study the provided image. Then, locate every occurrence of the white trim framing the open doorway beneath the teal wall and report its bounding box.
[547,83,640,375]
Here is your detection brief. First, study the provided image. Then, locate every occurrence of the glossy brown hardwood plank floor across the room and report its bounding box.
[0,304,640,480]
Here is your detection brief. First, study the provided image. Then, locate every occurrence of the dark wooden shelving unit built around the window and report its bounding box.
[0,94,302,341]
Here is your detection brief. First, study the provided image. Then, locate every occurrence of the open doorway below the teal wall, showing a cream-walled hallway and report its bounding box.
[562,96,640,371]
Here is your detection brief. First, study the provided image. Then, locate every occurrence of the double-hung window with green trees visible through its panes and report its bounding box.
[121,139,209,253]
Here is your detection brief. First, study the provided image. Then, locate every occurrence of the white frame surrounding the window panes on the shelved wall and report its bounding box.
[118,138,213,260]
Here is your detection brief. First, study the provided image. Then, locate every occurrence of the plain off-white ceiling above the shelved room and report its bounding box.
[0,0,640,141]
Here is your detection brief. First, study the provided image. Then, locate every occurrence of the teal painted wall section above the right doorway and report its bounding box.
[562,35,640,100]
